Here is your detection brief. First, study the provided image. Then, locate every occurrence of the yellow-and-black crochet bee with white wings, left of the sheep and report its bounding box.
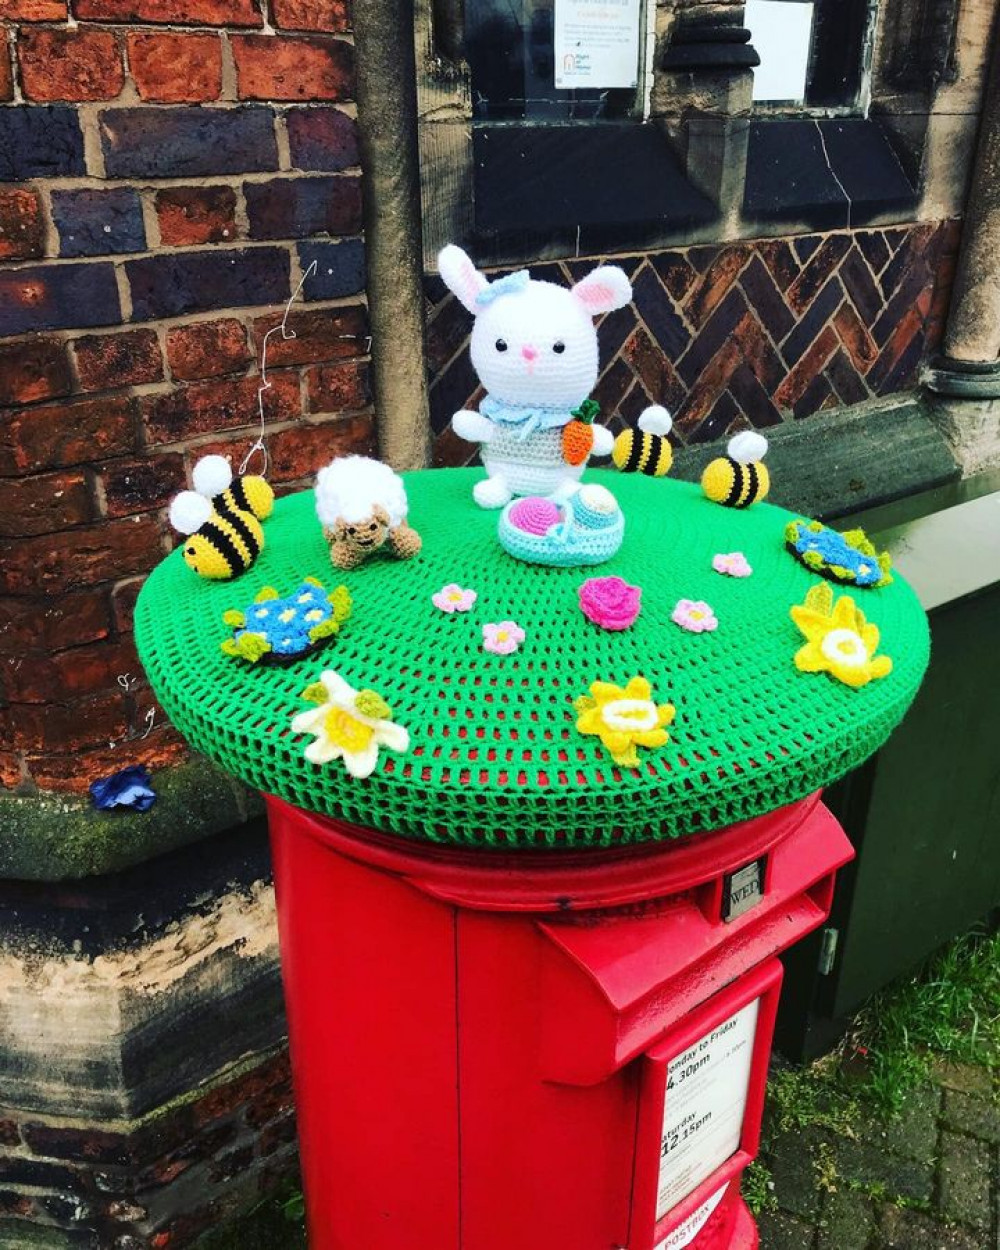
[170,456,274,581]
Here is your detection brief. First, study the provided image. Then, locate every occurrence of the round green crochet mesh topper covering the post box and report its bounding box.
[135,469,928,848]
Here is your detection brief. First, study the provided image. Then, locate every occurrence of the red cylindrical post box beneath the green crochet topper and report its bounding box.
[269,795,853,1250]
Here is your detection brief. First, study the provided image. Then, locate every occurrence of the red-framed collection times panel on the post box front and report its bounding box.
[629,961,781,1250]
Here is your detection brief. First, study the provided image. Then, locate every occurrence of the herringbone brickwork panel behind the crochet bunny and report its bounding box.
[426,221,959,465]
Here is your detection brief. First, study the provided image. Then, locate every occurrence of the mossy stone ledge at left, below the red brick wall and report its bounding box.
[0,755,264,881]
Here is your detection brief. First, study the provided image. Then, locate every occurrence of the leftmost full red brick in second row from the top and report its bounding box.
[18,29,125,101]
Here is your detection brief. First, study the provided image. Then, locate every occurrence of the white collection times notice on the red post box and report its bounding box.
[656,999,759,1220]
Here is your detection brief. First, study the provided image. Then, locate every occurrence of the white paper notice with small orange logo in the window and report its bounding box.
[555,0,643,91]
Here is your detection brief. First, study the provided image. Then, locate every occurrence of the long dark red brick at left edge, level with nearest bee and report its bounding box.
[0,516,164,595]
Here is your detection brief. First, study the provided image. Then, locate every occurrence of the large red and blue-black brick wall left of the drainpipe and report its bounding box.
[0,0,374,790]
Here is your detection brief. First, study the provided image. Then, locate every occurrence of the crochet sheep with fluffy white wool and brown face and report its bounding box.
[316,456,421,569]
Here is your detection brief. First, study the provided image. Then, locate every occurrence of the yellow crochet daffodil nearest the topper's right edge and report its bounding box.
[791,583,893,690]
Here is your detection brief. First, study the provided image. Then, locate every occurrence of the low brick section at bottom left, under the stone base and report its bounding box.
[0,1050,298,1250]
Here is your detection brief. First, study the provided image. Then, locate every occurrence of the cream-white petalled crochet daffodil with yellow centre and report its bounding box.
[291,671,410,778]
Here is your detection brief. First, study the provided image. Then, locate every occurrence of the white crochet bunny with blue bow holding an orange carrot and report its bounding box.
[438,245,633,508]
